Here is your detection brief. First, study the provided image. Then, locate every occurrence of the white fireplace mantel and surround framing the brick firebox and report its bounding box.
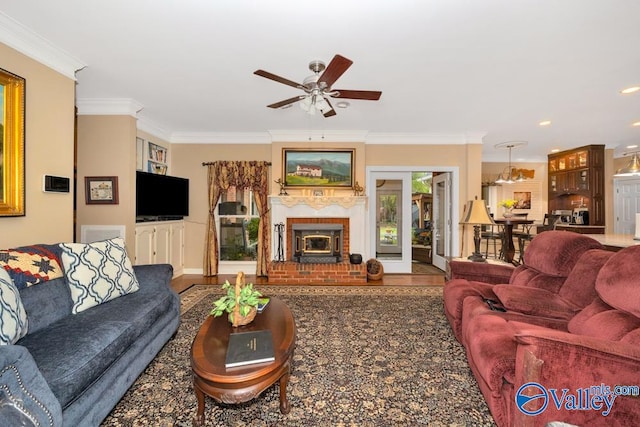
[269,196,367,259]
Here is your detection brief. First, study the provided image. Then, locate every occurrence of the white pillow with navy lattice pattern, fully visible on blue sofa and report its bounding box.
[60,237,139,314]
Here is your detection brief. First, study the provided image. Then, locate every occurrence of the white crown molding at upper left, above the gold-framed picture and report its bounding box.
[0,12,87,80]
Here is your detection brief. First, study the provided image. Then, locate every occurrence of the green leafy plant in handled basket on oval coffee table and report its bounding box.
[209,272,262,327]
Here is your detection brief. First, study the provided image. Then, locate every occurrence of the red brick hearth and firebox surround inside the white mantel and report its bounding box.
[269,218,367,285]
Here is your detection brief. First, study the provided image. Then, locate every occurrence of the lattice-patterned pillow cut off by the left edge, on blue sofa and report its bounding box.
[0,268,28,345]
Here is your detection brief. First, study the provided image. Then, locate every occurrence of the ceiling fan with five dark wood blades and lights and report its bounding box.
[253,55,382,117]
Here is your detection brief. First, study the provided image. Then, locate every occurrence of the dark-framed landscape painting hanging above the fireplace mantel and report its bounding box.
[282,148,354,188]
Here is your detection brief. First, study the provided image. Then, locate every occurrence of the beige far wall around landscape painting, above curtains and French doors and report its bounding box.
[170,142,481,269]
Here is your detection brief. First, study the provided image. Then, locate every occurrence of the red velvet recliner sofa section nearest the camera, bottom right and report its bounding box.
[447,232,640,426]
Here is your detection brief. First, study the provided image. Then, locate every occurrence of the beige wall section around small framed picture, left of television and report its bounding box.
[76,116,136,254]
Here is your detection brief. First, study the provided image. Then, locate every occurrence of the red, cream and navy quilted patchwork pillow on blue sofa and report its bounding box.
[0,245,62,289]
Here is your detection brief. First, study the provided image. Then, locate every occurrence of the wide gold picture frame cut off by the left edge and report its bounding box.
[0,68,25,216]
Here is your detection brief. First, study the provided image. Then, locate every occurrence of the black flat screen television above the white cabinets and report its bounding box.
[136,171,189,221]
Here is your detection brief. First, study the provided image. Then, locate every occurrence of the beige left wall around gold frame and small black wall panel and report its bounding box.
[0,43,75,248]
